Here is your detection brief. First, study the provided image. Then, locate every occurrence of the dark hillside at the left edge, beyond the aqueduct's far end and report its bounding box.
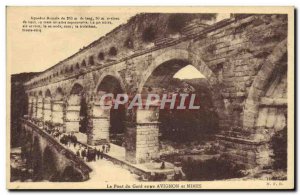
[10,73,38,147]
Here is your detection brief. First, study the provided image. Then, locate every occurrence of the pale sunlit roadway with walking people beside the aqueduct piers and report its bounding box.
[23,119,174,182]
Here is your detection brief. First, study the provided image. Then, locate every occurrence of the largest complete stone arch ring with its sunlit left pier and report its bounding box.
[126,49,228,163]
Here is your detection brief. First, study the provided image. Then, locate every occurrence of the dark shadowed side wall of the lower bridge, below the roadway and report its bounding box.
[22,119,92,181]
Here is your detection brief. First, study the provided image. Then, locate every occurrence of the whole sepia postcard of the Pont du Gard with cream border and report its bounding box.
[6,6,295,190]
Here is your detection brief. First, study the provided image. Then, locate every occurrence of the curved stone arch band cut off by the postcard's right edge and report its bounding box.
[243,39,287,128]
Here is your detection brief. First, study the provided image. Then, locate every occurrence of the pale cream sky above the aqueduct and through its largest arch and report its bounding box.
[7,7,229,76]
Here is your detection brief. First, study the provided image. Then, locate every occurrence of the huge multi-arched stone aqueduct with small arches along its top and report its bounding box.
[24,14,287,169]
